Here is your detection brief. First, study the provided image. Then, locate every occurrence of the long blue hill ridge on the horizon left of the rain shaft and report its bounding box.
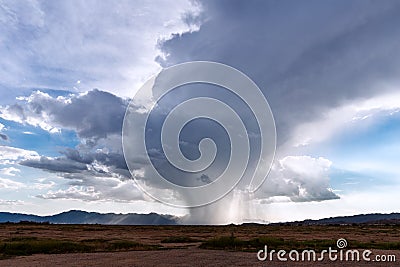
[0,210,177,225]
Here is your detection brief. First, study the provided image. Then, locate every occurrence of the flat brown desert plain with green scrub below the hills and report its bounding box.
[0,223,400,267]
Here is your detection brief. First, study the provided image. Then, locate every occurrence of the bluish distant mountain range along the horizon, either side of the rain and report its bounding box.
[0,210,400,225]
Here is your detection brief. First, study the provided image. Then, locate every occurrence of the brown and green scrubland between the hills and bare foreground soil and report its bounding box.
[0,224,400,258]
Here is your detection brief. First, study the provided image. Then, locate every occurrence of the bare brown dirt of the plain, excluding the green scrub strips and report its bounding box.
[0,224,400,267]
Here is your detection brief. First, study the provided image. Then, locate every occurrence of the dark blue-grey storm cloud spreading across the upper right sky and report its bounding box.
[158,0,400,144]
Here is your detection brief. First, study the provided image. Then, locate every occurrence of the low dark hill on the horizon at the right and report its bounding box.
[285,213,400,225]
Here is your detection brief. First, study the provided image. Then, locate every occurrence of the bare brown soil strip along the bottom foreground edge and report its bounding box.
[0,248,400,267]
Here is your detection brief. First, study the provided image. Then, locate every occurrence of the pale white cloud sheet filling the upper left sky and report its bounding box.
[0,0,200,96]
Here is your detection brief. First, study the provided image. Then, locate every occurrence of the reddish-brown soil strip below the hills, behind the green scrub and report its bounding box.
[0,224,400,244]
